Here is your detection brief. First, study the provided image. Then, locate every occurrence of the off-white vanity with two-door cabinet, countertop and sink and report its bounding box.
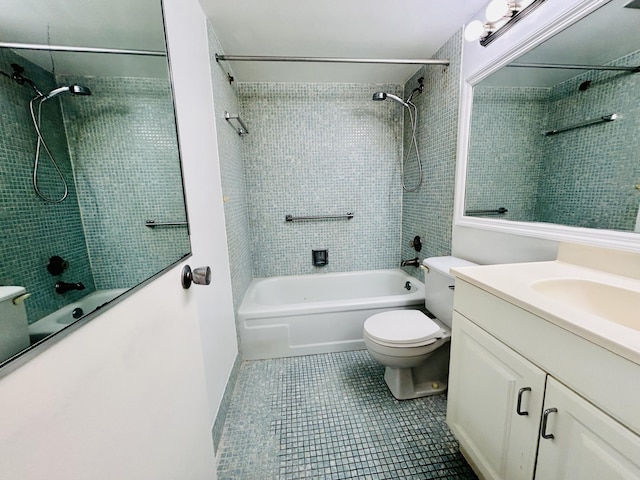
[447,244,640,480]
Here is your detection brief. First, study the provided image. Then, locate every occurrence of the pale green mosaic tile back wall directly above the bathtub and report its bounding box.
[238,83,402,277]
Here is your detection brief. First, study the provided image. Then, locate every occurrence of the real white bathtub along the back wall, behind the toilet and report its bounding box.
[238,269,424,360]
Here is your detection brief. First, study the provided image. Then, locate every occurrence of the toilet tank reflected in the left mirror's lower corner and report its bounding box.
[0,287,30,362]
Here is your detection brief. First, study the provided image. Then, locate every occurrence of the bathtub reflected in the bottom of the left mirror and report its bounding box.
[29,288,127,344]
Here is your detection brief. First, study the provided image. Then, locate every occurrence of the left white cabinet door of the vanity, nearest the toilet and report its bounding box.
[447,312,546,480]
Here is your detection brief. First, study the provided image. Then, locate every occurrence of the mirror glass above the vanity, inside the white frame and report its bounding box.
[464,0,640,232]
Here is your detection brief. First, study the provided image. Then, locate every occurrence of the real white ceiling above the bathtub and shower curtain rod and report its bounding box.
[201,0,488,84]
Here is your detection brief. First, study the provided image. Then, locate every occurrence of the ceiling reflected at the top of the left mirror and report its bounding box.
[0,0,167,77]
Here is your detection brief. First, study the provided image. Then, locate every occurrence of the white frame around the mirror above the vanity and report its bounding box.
[453,0,640,252]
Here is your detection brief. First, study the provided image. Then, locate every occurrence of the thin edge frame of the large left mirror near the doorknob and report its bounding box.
[0,0,193,379]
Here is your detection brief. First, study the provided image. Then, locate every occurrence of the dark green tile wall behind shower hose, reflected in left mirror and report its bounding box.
[0,49,94,323]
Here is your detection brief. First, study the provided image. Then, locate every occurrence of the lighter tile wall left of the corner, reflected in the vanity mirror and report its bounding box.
[465,86,549,221]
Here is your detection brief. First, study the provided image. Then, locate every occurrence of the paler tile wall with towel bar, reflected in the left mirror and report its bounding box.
[59,77,190,289]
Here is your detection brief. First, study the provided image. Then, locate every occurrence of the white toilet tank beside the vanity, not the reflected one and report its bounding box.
[422,257,477,327]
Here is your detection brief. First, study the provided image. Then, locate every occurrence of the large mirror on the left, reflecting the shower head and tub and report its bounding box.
[0,0,190,369]
